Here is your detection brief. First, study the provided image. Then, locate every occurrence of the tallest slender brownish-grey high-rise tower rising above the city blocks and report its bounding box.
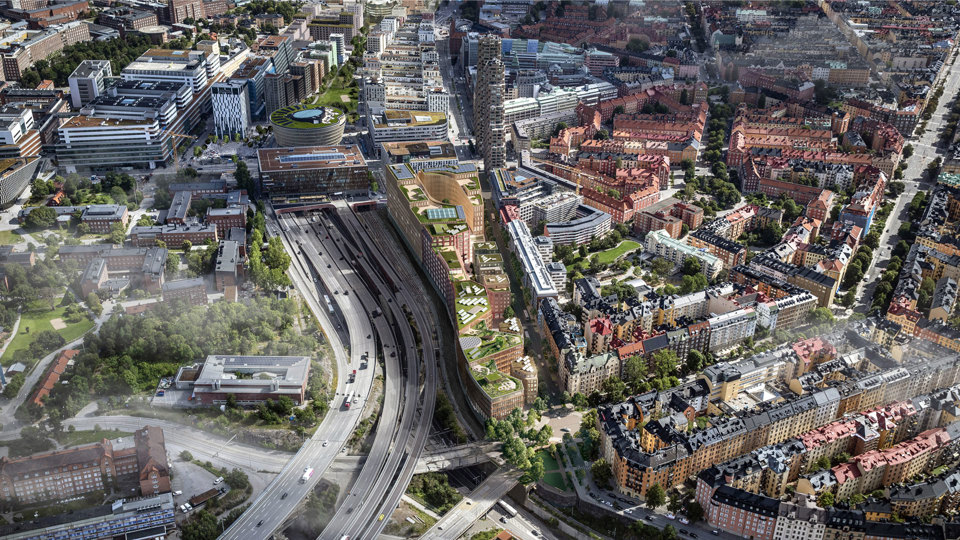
[473,35,507,171]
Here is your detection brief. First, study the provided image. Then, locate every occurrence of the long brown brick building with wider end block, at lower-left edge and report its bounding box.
[0,426,170,504]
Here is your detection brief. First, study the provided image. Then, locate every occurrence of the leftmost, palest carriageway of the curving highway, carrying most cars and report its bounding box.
[221,205,376,540]
